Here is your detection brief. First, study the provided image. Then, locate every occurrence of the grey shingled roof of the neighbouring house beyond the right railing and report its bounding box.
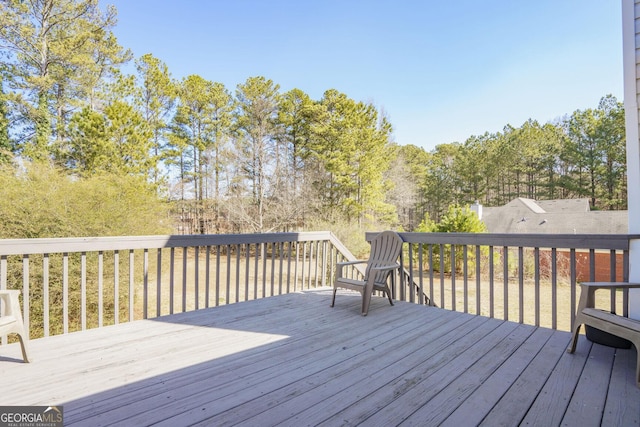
[480,197,628,234]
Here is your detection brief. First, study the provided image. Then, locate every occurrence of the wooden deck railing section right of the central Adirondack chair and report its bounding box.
[366,233,637,330]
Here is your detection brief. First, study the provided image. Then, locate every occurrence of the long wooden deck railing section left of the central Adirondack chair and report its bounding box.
[0,232,360,341]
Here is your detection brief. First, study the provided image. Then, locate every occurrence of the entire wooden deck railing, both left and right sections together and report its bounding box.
[0,232,636,342]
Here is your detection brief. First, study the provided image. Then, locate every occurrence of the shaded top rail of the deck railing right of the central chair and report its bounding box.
[365,232,640,250]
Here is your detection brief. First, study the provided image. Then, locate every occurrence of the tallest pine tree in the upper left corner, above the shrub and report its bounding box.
[0,0,130,161]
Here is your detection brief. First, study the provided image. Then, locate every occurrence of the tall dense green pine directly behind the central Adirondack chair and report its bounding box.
[310,90,395,224]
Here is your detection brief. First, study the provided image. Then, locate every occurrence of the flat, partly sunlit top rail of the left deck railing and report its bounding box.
[0,231,337,256]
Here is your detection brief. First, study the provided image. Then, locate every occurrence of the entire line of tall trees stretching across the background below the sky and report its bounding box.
[0,0,626,237]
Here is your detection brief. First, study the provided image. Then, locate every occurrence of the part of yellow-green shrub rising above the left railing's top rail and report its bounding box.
[0,164,170,239]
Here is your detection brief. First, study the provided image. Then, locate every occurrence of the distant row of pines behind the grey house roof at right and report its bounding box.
[395,95,627,229]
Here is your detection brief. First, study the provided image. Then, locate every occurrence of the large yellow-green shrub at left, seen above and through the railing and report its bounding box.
[0,164,170,337]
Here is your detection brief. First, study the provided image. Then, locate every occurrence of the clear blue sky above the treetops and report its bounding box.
[102,0,623,151]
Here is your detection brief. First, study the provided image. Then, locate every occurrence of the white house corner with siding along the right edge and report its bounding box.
[622,0,640,319]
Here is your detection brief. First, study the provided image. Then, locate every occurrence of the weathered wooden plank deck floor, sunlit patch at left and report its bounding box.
[0,290,640,427]
